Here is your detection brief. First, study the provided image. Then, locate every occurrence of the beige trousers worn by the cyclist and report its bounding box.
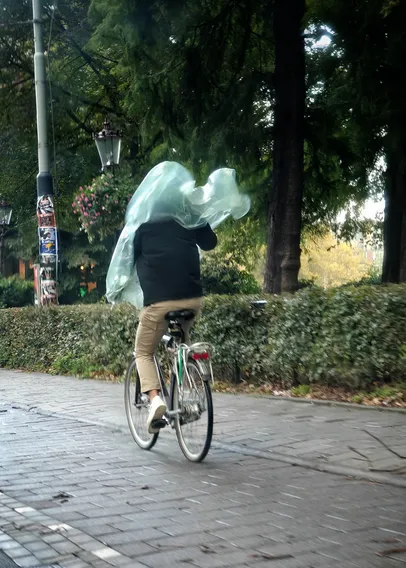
[135,298,202,392]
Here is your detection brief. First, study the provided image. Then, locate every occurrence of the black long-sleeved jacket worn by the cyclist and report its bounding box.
[134,221,217,306]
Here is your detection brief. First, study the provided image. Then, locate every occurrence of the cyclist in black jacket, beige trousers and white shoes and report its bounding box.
[134,220,217,434]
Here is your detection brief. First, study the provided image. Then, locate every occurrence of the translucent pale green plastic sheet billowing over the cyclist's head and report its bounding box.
[106,162,250,308]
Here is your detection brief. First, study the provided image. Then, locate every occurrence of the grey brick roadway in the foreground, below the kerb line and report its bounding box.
[0,400,406,568]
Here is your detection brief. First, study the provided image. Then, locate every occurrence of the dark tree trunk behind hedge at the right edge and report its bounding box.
[382,152,406,283]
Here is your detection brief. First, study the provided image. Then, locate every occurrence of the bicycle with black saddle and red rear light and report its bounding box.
[124,310,213,462]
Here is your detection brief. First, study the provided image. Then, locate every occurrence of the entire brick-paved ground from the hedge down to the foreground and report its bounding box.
[0,370,406,568]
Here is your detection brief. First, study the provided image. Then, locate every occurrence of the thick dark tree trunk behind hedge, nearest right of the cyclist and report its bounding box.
[264,0,305,294]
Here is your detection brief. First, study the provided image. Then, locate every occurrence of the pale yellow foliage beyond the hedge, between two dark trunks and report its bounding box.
[301,233,371,288]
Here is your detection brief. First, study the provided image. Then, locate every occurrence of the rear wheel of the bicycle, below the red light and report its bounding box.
[172,361,213,462]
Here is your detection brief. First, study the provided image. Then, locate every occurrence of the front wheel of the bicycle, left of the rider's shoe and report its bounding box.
[124,359,159,450]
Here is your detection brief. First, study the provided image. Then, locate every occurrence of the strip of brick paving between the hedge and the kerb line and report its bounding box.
[0,369,406,486]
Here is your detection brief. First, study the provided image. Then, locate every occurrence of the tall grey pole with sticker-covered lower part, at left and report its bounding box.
[32,0,58,306]
